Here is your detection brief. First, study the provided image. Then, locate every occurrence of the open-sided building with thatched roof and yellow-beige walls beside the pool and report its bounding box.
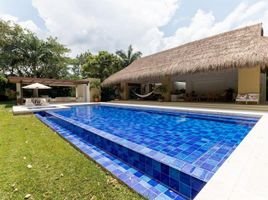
[102,24,268,104]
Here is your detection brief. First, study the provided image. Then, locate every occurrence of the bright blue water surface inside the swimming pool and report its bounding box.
[50,105,258,173]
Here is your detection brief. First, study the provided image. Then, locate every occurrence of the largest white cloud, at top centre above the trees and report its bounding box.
[30,0,179,54]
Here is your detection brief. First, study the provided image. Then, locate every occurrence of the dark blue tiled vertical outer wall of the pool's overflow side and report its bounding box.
[42,113,206,199]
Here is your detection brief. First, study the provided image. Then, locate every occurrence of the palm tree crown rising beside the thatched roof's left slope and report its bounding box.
[116,45,142,67]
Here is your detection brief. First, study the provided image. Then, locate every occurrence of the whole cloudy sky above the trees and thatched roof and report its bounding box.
[0,0,268,56]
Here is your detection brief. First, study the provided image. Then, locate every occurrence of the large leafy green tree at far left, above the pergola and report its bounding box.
[0,20,69,78]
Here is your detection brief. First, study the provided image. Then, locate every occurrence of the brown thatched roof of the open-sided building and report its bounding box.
[103,24,268,86]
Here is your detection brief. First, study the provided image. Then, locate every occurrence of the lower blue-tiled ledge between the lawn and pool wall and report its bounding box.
[35,114,185,200]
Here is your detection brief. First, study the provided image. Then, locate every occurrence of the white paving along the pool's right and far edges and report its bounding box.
[100,103,268,200]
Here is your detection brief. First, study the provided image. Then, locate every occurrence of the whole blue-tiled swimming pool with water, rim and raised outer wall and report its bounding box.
[36,105,259,199]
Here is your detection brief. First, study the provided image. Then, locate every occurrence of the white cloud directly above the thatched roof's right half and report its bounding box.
[163,1,268,49]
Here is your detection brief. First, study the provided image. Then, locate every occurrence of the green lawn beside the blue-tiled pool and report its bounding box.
[0,103,142,200]
